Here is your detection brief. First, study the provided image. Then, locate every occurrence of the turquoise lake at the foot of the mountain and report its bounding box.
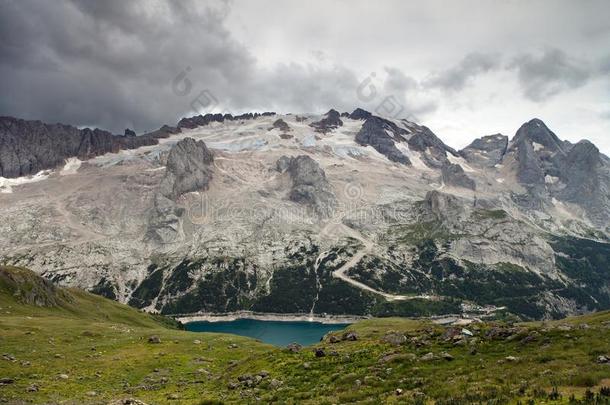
[185,319,349,346]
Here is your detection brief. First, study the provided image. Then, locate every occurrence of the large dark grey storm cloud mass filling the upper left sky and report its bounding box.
[0,0,370,132]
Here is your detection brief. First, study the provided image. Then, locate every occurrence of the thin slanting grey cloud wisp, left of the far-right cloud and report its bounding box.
[424,52,500,91]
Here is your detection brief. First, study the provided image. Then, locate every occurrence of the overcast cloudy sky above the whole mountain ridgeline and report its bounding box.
[0,0,610,155]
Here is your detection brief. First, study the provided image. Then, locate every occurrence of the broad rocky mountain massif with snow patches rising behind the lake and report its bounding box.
[0,109,610,319]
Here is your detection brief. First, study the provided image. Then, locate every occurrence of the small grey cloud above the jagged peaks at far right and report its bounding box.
[508,48,591,101]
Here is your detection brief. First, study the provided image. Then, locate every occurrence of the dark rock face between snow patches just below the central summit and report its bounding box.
[354,115,411,165]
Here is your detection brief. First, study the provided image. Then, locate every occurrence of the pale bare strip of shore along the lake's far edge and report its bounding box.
[172,311,367,324]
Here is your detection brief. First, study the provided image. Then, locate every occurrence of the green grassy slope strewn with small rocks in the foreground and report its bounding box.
[0,269,610,404]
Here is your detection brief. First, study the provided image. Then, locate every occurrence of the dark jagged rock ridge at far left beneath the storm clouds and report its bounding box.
[0,117,158,178]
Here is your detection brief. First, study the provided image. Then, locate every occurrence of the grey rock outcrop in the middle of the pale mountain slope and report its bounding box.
[277,155,336,216]
